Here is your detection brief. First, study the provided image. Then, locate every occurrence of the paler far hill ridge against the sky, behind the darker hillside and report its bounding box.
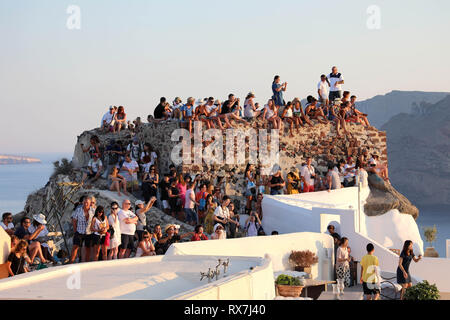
[356,90,450,129]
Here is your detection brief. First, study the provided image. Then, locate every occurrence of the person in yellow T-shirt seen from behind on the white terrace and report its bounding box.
[360,243,380,300]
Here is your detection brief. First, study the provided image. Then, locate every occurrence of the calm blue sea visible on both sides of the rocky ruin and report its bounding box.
[0,153,450,257]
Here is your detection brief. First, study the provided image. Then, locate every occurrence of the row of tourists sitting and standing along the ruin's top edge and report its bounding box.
[101,66,370,137]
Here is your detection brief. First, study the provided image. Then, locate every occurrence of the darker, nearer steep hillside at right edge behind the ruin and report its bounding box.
[381,95,450,205]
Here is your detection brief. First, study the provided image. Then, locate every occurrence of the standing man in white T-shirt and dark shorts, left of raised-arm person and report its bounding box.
[118,199,139,259]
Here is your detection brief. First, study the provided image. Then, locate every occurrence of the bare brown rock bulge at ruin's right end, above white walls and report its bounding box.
[364,174,419,219]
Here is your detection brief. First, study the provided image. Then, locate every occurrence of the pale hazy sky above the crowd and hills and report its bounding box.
[0,0,450,153]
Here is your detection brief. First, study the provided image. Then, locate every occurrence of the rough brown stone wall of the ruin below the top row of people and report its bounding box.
[73,120,387,212]
